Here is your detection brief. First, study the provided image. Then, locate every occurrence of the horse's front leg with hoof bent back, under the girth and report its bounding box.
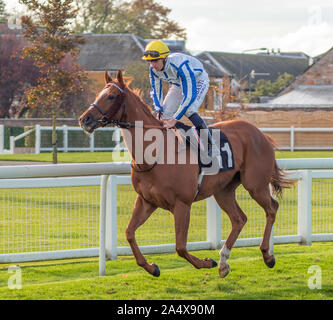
[173,201,217,269]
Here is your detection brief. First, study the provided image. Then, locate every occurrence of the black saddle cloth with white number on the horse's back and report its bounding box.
[176,121,234,175]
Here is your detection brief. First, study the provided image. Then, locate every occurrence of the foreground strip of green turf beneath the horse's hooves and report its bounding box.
[0,242,333,300]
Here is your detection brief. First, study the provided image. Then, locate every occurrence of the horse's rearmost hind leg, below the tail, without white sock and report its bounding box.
[249,185,279,268]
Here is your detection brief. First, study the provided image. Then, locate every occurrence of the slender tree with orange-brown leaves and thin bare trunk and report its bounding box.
[20,0,87,163]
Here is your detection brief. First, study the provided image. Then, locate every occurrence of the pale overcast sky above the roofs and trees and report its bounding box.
[5,0,333,56]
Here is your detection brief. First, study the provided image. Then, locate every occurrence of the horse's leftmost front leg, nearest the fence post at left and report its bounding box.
[125,195,160,277]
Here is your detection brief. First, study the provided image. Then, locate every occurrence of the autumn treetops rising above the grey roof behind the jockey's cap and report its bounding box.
[74,0,186,39]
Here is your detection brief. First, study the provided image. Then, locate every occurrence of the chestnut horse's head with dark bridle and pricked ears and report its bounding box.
[79,70,126,133]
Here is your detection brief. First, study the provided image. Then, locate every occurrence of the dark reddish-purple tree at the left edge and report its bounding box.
[0,30,40,118]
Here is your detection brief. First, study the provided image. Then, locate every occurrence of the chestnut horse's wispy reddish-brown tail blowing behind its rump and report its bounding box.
[265,134,297,199]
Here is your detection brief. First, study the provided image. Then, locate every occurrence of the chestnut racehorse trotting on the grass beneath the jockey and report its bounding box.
[79,71,292,277]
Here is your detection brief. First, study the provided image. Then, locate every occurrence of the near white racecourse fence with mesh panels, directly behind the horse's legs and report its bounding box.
[0,159,333,274]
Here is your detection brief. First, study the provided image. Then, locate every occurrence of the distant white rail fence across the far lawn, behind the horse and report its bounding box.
[0,125,333,154]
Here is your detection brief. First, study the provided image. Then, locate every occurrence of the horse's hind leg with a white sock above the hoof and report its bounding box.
[214,185,247,278]
